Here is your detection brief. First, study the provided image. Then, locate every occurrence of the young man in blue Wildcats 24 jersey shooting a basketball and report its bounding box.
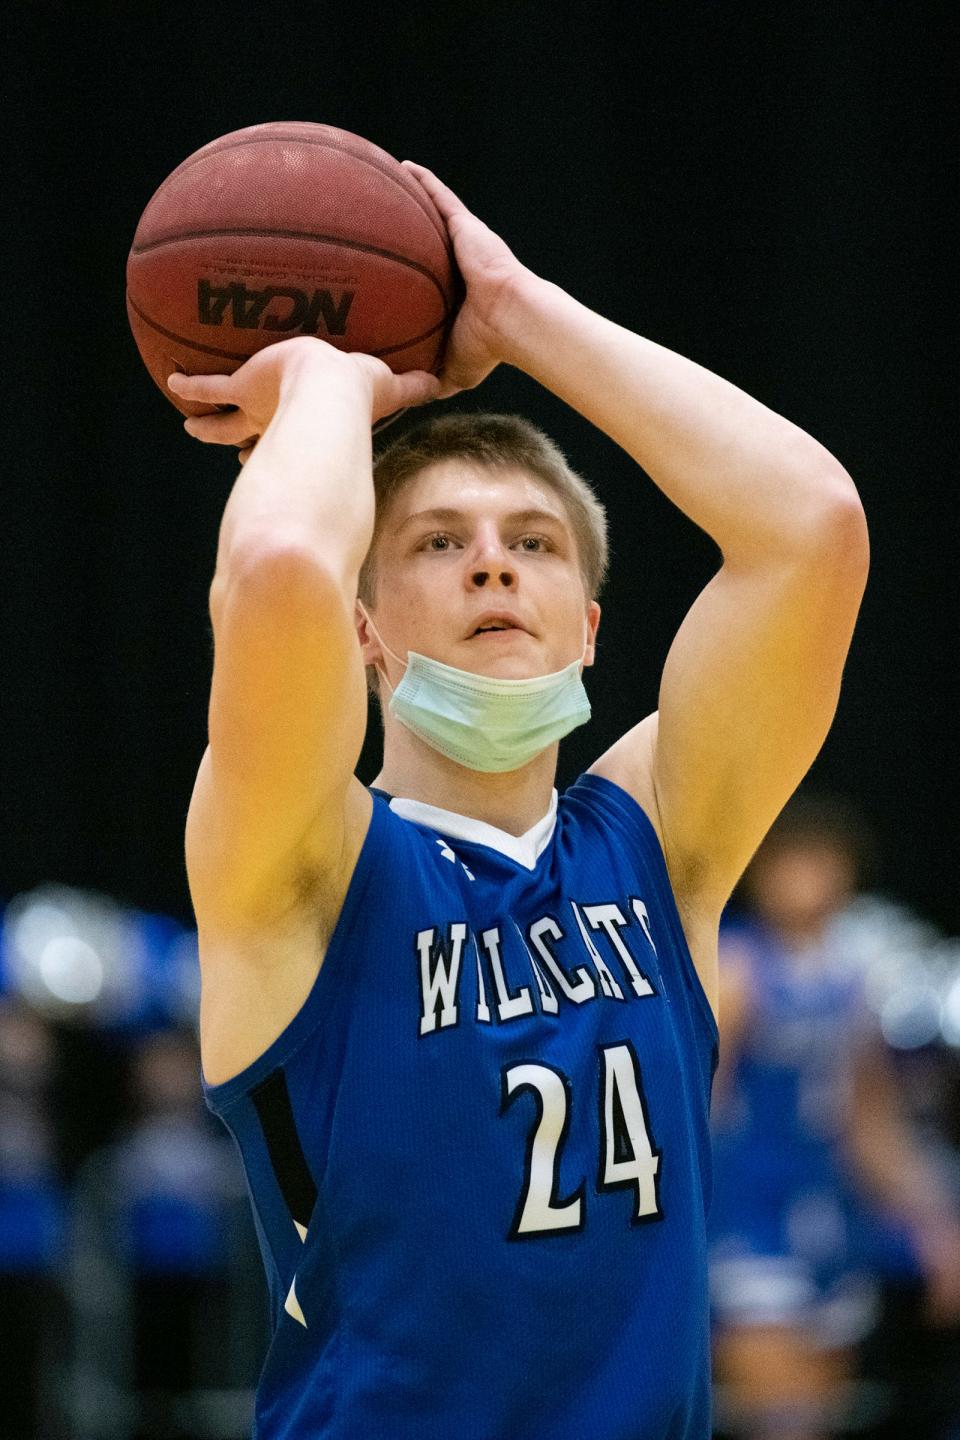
[171,167,868,1440]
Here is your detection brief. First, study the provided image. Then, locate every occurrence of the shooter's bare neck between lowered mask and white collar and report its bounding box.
[373,714,558,835]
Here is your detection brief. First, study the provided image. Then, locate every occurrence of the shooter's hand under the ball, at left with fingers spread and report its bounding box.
[167,336,439,461]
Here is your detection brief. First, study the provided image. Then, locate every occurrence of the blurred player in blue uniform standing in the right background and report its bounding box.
[710,793,960,1440]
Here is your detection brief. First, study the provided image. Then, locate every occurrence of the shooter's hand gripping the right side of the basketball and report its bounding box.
[403,160,530,399]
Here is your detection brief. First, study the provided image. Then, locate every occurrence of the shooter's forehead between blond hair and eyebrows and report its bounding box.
[386,458,569,531]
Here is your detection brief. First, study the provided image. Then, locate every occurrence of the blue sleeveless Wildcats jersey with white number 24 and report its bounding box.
[206,776,717,1440]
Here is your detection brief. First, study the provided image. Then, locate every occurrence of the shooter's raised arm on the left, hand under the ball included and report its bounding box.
[170,338,436,933]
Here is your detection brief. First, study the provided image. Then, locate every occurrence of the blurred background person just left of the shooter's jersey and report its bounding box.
[73,1028,251,1440]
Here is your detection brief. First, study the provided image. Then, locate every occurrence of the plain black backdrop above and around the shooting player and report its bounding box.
[0,0,960,932]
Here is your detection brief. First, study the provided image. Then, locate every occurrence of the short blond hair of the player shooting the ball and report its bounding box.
[357,412,609,606]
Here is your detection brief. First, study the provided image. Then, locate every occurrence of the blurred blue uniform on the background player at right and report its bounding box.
[710,919,886,1344]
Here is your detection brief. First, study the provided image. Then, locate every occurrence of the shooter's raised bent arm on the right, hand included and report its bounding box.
[413,167,868,950]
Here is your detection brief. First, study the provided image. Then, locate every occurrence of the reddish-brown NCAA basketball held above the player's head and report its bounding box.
[127,121,459,415]
